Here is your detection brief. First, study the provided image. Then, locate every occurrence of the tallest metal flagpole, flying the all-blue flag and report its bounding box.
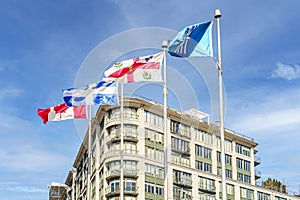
[215,9,227,200]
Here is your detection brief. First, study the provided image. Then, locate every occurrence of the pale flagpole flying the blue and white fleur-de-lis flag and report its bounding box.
[120,83,124,200]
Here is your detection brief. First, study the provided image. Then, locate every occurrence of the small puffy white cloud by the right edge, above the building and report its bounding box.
[272,63,300,81]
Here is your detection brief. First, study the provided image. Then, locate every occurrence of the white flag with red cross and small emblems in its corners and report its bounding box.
[104,52,163,83]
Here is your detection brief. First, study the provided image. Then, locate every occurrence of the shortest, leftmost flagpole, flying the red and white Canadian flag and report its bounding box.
[87,105,92,200]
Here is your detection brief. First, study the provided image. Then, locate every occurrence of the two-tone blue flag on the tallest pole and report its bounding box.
[168,21,213,58]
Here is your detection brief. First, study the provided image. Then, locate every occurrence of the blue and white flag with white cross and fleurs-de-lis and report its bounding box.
[63,81,118,106]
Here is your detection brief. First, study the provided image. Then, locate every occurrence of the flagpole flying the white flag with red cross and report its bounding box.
[162,41,169,200]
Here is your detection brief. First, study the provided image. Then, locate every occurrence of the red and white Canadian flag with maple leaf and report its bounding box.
[38,103,87,124]
